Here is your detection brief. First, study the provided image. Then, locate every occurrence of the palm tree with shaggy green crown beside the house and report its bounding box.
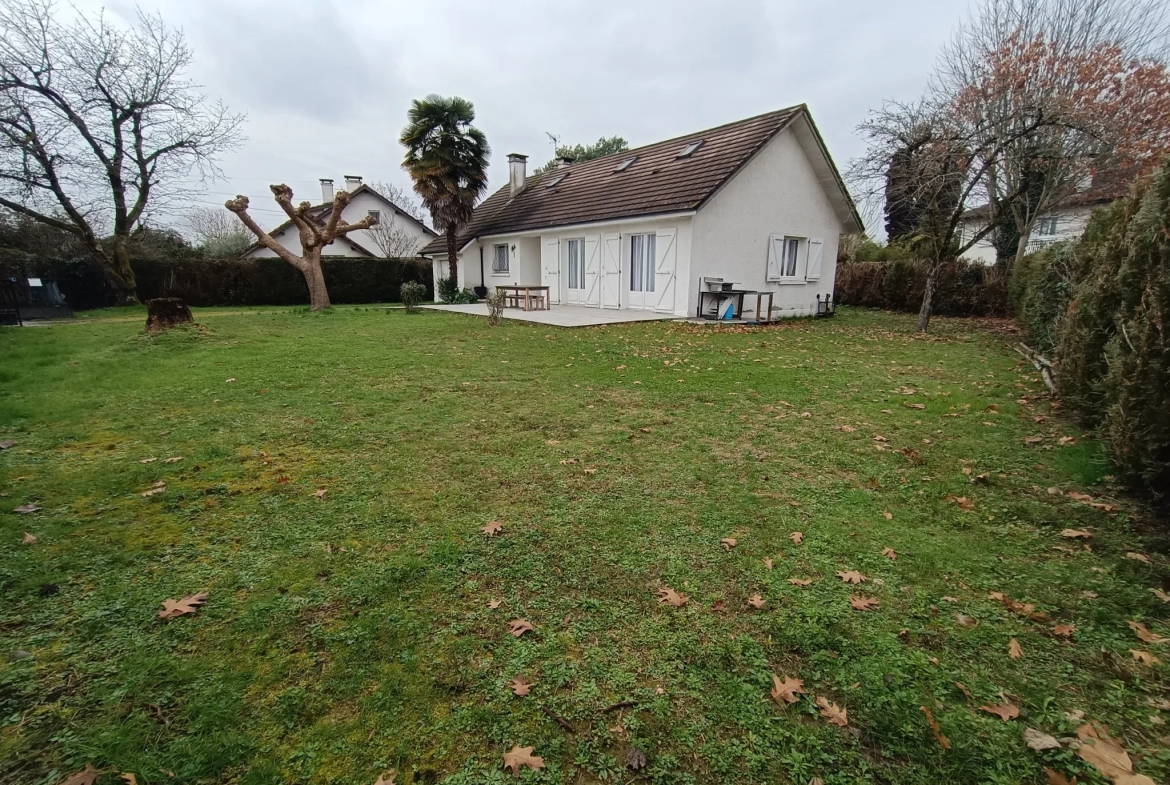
[399,95,491,282]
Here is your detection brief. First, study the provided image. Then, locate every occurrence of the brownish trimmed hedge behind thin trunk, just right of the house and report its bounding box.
[834,260,1007,316]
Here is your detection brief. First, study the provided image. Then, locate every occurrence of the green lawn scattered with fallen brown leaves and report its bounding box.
[0,308,1170,785]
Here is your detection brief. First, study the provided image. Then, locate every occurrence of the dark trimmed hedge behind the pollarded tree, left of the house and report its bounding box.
[0,250,434,310]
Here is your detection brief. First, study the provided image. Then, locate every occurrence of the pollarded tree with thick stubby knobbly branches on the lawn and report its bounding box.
[223,184,378,311]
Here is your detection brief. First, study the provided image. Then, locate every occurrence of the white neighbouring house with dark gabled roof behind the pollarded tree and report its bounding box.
[242,175,436,257]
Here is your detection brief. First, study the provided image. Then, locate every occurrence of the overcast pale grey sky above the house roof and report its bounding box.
[78,0,968,231]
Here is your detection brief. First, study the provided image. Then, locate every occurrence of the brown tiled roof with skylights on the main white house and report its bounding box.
[420,104,861,254]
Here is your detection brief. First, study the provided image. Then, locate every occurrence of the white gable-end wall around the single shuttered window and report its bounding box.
[686,126,846,316]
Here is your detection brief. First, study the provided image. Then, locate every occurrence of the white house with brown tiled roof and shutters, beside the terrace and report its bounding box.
[422,104,862,316]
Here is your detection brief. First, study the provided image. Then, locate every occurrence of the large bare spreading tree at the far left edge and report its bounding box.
[0,0,243,303]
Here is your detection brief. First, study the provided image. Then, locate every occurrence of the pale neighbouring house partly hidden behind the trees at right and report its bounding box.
[959,173,1128,264]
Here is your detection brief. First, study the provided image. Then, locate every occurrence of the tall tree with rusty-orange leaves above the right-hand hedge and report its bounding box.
[936,0,1170,263]
